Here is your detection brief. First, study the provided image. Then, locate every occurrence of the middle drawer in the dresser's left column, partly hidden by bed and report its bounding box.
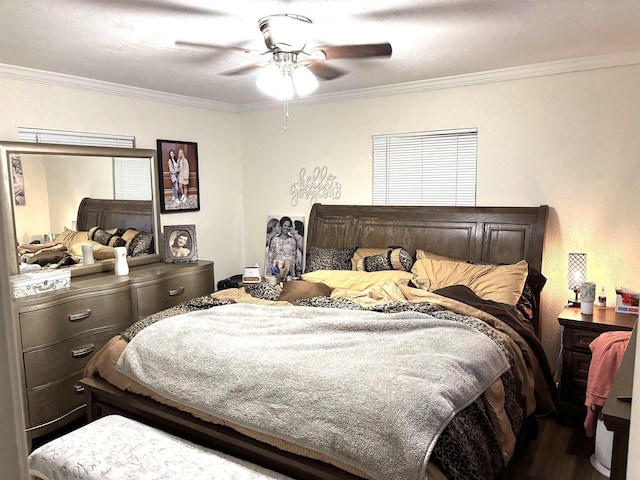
[24,323,129,388]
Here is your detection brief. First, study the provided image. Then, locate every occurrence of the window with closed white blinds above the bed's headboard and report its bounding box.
[373,128,478,206]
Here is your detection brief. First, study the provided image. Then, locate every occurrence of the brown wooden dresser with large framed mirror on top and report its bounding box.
[0,142,214,442]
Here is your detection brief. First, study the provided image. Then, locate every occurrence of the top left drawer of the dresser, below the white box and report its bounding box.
[19,289,132,349]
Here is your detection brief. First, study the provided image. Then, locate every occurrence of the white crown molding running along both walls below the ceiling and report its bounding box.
[0,52,640,113]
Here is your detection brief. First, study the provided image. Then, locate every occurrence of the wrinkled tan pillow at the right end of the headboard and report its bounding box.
[411,258,528,305]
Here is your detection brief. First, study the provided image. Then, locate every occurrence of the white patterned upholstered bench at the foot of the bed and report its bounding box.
[28,415,291,480]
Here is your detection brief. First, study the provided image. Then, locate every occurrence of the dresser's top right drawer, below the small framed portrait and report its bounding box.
[134,270,213,318]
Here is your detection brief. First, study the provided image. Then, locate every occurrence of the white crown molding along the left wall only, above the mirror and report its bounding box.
[0,63,238,113]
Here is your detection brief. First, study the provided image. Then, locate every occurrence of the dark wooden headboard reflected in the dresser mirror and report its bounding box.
[76,198,154,232]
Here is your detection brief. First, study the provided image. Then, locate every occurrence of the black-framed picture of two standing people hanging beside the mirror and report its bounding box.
[156,140,200,213]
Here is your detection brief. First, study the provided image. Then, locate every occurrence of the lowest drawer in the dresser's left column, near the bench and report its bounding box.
[27,370,85,427]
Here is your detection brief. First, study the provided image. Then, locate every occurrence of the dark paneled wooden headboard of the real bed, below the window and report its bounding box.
[307,204,549,336]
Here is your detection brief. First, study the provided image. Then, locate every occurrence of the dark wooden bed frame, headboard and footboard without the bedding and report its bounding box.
[81,205,548,480]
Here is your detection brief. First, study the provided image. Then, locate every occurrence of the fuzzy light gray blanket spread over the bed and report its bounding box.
[118,304,509,480]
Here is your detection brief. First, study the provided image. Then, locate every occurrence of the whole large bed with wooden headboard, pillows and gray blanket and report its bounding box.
[82,204,556,480]
